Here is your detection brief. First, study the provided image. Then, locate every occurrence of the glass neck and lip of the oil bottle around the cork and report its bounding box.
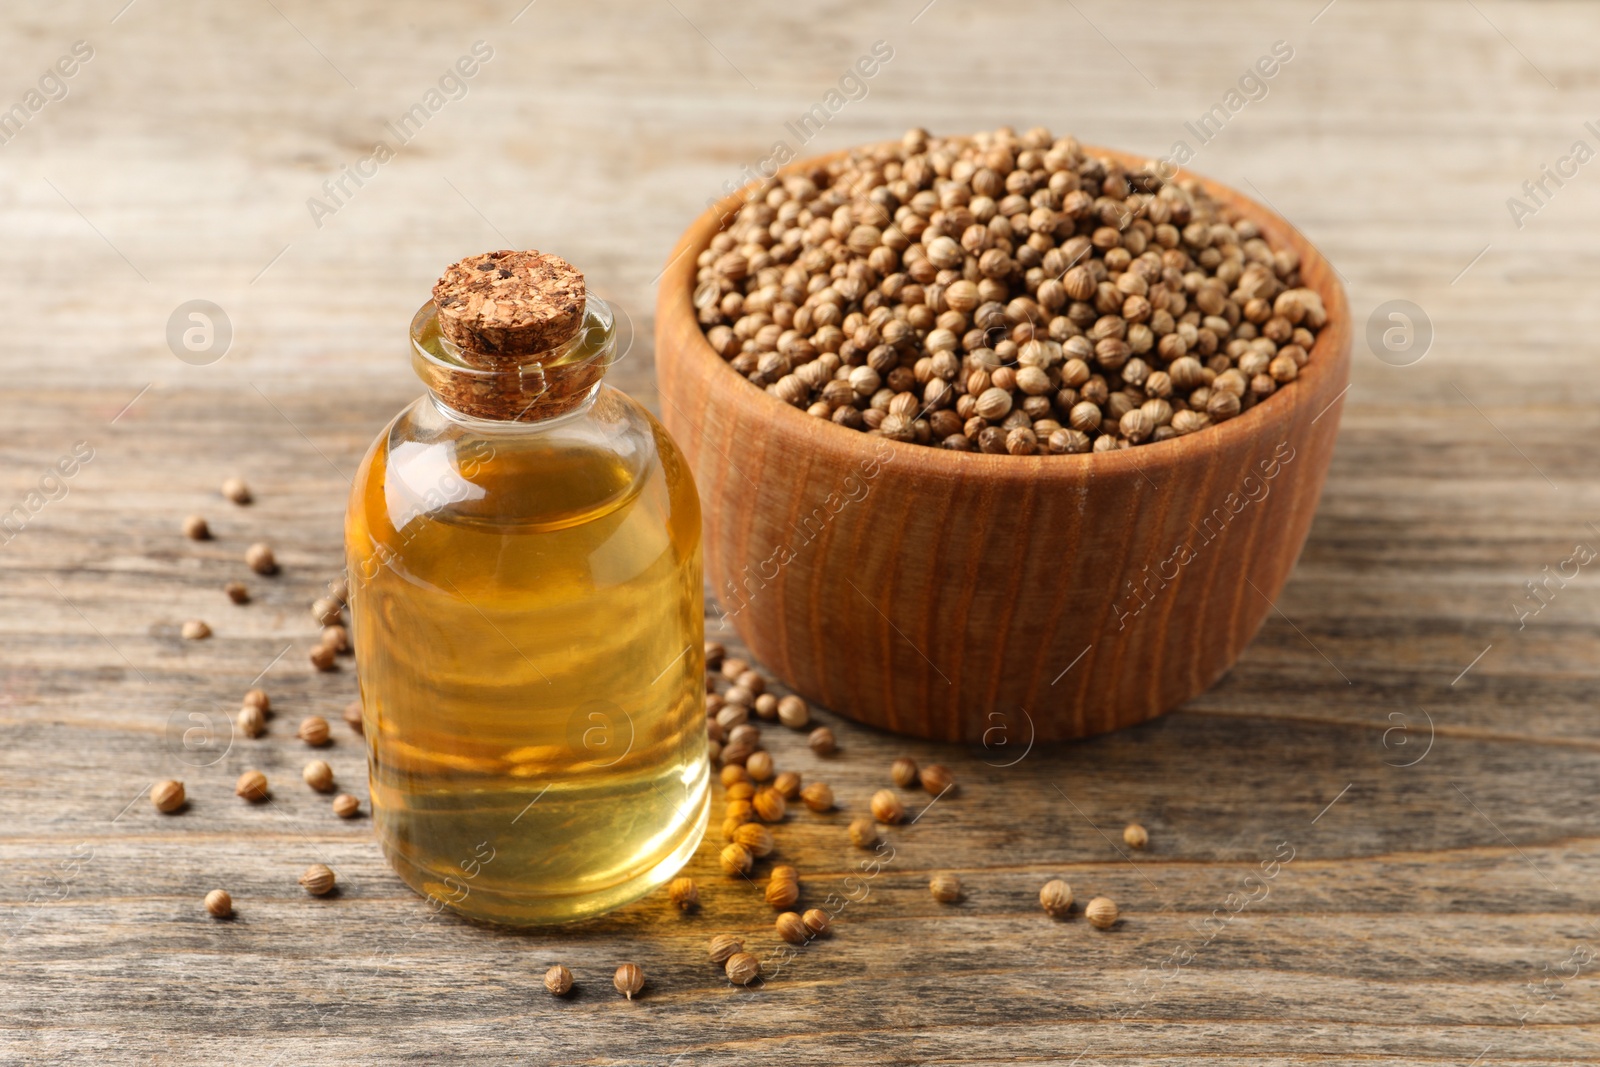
[411,296,616,424]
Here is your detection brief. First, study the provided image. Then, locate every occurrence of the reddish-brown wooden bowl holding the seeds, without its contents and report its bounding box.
[656,149,1350,752]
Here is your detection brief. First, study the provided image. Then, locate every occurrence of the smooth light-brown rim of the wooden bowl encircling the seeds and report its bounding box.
[656,141,1350,482]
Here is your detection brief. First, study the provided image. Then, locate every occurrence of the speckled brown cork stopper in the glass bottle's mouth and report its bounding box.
[434,250,587,368]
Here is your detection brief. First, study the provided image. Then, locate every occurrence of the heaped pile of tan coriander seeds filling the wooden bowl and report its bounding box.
[694,126,1326,456]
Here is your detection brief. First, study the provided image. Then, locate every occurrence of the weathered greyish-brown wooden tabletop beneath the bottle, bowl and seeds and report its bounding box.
[0,0,1600,1067]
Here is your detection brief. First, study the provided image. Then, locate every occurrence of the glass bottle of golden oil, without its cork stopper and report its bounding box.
[346,253,709,925]
